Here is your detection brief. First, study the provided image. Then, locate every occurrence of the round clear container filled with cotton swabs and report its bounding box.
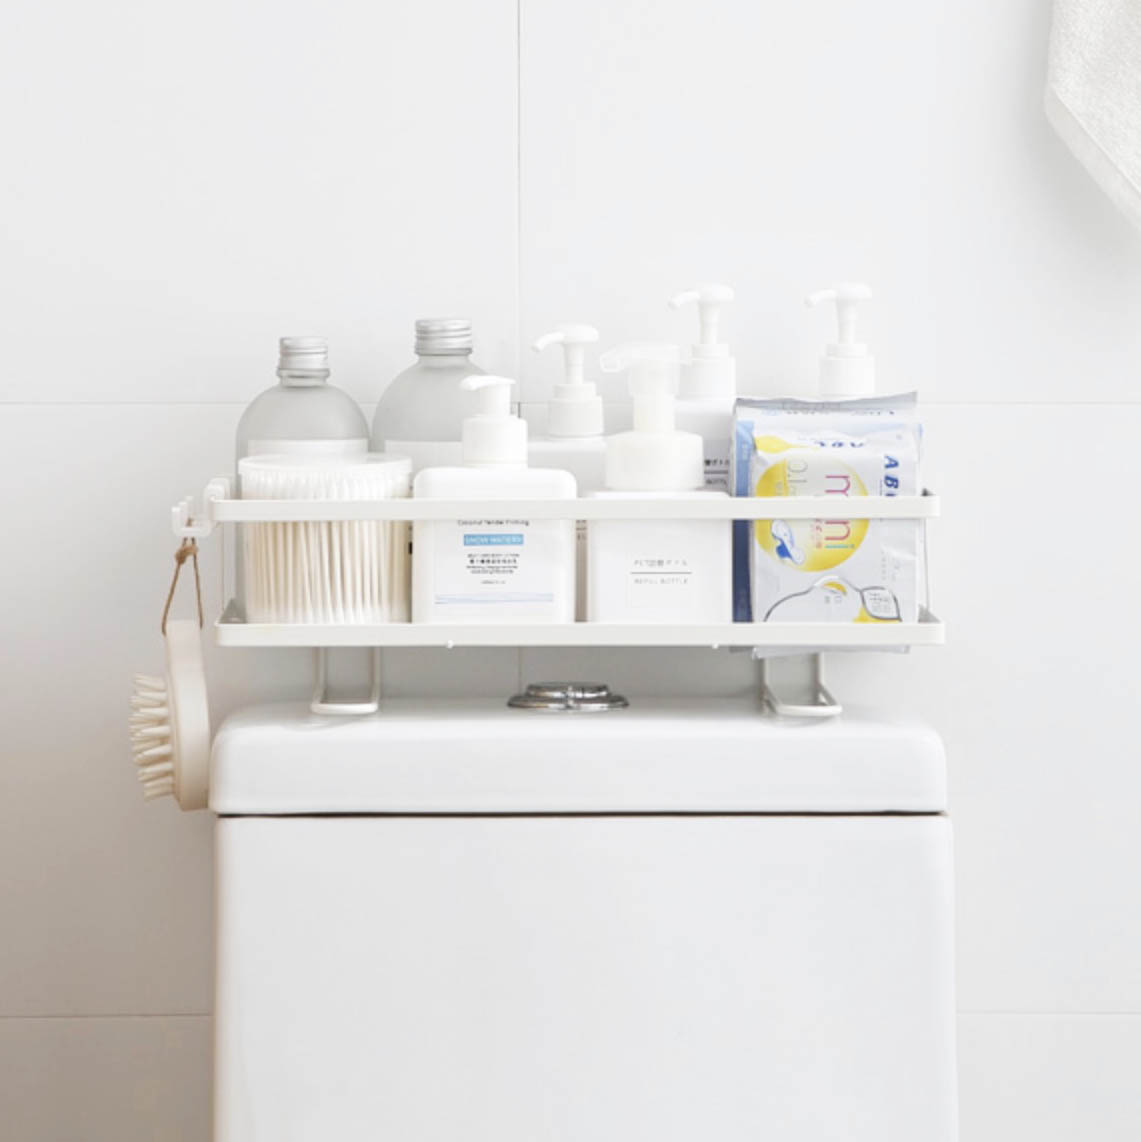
[239,453,412,624]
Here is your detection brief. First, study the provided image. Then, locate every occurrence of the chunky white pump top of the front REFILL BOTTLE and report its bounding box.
[598,344,705,492]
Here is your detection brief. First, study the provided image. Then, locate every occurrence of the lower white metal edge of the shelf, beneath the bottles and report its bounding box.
[215,611,945,650]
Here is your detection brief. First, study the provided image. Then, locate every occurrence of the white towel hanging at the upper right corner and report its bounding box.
[1046,0,1141,227]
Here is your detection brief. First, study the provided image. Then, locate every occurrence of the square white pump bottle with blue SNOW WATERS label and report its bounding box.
[412,375,576,624]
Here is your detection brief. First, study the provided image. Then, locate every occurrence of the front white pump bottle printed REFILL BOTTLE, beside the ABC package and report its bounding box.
[587,345,732,624]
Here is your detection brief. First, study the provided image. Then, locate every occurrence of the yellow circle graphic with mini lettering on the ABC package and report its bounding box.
[753,454,869,572]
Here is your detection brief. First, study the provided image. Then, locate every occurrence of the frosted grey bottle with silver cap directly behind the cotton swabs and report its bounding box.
[236,337,369,470]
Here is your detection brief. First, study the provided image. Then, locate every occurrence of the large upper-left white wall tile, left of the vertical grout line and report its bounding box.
[0,0,516,401]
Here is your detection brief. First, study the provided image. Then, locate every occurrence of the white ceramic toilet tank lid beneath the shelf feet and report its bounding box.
[210,700,947,815]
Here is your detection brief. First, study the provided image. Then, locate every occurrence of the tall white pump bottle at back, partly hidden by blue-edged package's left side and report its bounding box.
[669,283,737,492]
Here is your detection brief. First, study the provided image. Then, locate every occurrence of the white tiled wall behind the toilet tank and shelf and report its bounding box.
[0,0,1141,1142]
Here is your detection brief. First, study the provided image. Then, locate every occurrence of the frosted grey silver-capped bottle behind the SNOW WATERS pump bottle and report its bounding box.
[372,317,483,473]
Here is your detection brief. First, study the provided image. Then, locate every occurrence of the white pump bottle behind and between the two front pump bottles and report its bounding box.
[528,325,606,619]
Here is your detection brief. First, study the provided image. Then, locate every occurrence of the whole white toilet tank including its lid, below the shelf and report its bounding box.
[211,701,957,1142]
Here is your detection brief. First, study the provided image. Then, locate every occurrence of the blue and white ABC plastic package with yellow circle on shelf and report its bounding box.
[733,393,923,622]
